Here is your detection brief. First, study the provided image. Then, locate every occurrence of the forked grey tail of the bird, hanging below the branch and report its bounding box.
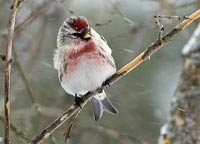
[92,91,118,121]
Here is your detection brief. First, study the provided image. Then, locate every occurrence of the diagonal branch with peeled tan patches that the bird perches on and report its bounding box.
[28,9,200,144]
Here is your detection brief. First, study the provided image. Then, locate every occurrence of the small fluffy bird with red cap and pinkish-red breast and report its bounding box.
[54,16,117,121]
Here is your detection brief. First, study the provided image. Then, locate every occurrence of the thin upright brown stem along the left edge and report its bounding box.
[4,0,23,144]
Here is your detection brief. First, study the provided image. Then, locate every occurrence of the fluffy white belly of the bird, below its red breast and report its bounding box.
[59,59,116,95]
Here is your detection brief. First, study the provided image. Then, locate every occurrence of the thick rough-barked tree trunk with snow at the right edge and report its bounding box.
[158,23,200,144]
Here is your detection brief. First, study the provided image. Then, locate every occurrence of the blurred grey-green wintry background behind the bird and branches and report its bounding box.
[0,0,200,144]
